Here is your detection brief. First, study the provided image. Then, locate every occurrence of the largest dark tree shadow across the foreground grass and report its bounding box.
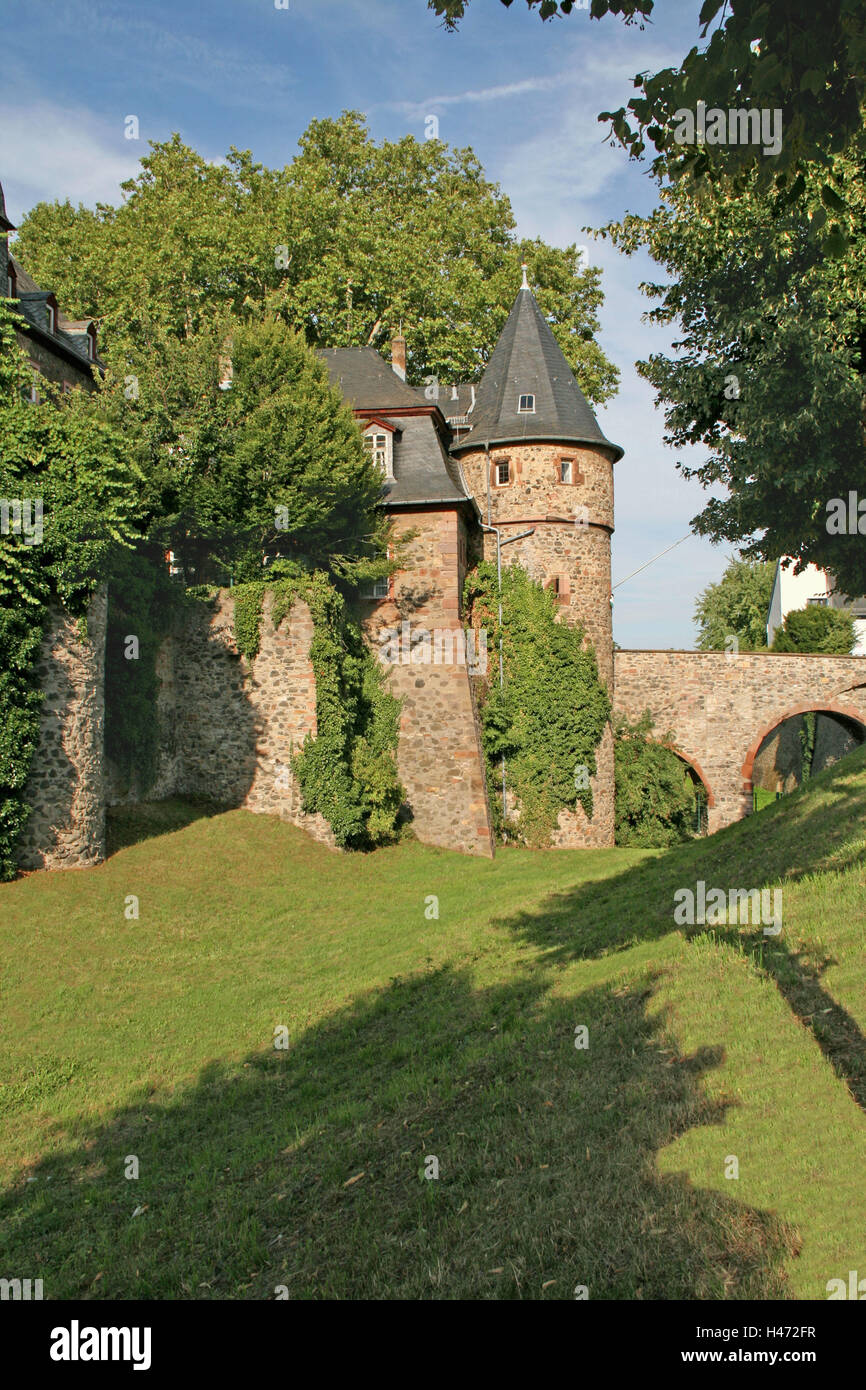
[0,969,795,1300]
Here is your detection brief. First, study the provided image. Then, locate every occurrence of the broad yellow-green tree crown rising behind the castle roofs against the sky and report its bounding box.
[15,113,617,403]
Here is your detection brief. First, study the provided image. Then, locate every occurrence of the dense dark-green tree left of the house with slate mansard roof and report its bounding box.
[93,314,385,582]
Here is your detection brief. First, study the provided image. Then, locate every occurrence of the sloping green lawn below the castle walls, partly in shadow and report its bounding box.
[0,752,866,1298]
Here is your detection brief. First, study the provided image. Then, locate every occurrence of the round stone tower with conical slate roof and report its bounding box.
[452,270,623,845]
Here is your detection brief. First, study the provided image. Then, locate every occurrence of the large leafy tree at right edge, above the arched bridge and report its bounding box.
[605,132,866,594]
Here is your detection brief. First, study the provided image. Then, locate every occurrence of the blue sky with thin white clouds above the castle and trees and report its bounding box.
[0,0,728,648]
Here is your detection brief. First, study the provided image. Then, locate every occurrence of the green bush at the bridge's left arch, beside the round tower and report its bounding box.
[613,710,695,849]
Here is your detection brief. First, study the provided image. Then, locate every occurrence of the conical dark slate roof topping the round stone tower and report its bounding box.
[452,285,624,461]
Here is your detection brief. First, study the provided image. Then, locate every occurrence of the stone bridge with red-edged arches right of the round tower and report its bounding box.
[614,651,866,833]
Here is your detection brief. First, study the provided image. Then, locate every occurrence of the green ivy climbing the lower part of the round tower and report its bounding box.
[464,560,610,845]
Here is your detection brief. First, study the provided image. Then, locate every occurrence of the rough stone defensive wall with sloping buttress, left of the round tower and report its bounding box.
[18,589,492,870]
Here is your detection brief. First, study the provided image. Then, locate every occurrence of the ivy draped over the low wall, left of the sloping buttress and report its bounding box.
[232,560,405,849]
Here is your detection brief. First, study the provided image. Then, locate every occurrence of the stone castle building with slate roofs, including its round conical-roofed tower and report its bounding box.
[320,272,623,852]
